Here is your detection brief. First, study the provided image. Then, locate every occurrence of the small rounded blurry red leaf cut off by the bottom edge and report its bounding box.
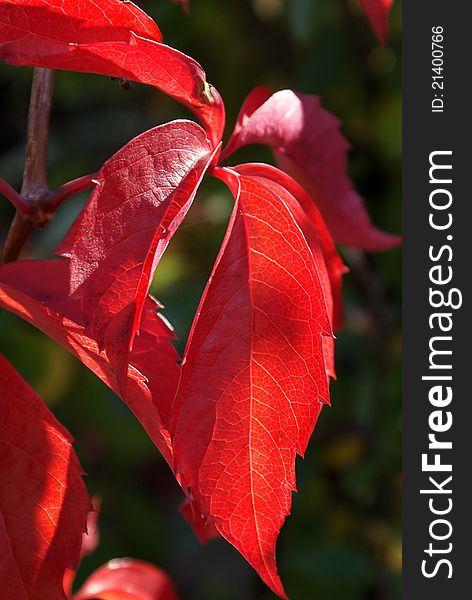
[73,558,177,600]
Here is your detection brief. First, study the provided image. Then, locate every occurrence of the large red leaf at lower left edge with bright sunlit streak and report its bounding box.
[0,355,90,600]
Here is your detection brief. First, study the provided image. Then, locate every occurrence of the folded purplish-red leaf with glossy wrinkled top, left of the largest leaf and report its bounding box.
[58,121,216,392]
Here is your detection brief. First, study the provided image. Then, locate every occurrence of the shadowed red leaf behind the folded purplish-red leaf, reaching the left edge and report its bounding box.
[0,260,179,464]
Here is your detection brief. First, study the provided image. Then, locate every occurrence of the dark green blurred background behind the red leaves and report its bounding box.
[0,0,401,600]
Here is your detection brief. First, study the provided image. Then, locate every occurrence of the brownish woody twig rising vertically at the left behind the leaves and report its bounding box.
[1,67,54,263]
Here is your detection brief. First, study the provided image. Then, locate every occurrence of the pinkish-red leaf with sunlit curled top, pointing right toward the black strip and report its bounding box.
[224,90,400,250]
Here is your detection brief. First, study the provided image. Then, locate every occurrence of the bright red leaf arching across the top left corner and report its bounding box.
[0,0,224,146]
